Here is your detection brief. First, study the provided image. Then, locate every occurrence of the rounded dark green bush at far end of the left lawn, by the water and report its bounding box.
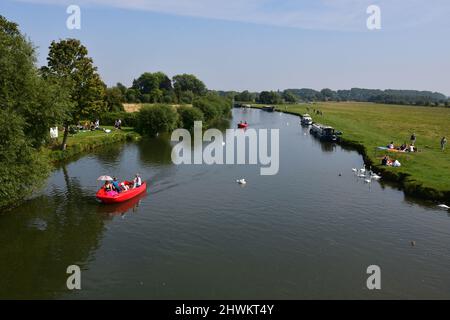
[136,104,178,136]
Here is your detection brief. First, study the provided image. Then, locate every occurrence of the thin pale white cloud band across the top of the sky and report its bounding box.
[17,0,450,31]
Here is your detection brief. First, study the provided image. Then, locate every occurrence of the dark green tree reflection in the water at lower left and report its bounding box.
[0,168,103,299]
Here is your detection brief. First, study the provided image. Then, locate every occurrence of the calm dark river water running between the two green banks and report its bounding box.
[0,109,450,299]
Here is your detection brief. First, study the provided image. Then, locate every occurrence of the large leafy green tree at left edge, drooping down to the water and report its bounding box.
[0,16,70,209]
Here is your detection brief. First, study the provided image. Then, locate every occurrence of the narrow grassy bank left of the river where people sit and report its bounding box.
[47,127,140,163]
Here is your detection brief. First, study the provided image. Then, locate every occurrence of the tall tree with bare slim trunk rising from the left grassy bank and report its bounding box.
[42,39,107,149]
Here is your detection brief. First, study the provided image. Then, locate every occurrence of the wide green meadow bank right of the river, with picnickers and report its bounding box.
[252,102,450,201]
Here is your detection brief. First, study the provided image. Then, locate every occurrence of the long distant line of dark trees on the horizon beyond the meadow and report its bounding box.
[229,88,450,107]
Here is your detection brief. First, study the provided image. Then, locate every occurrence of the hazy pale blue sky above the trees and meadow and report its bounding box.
[0,0,450,95]
